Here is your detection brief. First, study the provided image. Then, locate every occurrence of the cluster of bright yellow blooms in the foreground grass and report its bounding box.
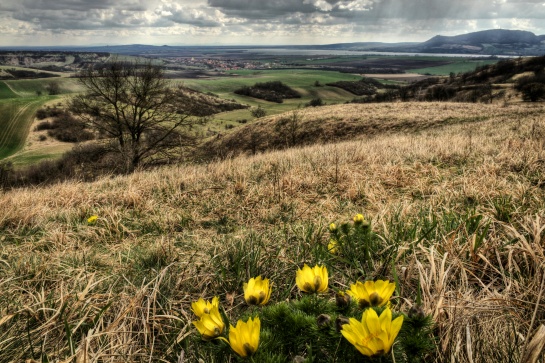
[191,230,403,358]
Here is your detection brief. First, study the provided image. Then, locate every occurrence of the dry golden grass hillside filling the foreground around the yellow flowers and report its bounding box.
[0,103,545,362]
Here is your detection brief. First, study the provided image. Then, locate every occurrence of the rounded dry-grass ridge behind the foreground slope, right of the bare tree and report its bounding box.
[199,102,540,159]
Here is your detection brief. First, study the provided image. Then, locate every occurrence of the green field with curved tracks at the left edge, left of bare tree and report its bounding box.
[0,97,48,159]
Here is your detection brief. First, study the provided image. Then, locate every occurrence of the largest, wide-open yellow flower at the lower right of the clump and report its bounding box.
[341,308,403,357]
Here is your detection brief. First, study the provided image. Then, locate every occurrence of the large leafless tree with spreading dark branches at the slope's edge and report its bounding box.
[70,59,198,170]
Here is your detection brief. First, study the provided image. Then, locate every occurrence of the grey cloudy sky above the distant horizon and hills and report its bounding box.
[0,0,545,46]
